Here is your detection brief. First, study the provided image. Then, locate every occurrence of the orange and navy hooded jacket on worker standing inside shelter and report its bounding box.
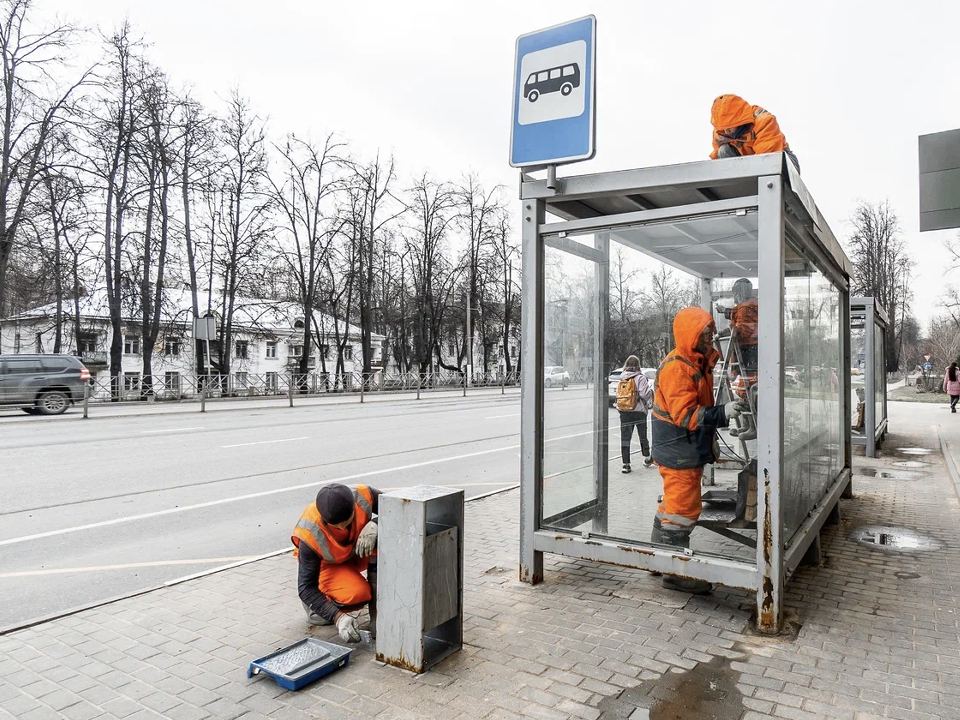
[652,307,727,469]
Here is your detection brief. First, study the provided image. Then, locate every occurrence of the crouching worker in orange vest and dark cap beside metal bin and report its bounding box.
[290,484,380,642]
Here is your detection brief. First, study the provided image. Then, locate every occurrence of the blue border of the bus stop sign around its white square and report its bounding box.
[510,15,597,167]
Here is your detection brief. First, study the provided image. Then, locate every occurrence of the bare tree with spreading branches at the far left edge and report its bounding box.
[0,0,89,317]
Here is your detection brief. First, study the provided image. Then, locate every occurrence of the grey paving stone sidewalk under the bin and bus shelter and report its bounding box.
[0,402,960,720]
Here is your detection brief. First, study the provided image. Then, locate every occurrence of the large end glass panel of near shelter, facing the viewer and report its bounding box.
[541,209,758,562]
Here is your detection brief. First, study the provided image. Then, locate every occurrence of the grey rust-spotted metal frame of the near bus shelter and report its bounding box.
[520,154,851,632]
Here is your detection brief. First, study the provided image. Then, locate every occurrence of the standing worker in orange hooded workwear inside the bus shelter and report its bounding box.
[650,307,742,593]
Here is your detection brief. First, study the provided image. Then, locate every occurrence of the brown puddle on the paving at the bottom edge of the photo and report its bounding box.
[597,657,745,720]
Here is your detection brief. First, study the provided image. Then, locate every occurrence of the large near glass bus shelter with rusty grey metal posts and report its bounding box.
[520,153,851,632]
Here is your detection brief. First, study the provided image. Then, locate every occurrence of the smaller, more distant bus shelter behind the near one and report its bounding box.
[850,297,889,457]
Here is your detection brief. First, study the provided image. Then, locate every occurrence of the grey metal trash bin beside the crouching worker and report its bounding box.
[377,485,463,672]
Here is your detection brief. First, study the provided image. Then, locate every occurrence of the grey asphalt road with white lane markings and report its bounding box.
[0,388,592,628]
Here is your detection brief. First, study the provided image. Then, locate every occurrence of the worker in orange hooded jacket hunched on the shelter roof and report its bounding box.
[710,95,800,170]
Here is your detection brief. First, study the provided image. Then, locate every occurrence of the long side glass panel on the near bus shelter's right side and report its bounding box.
[781,245,847,541]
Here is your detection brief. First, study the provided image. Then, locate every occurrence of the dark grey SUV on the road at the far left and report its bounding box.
[0,355,90,415]
